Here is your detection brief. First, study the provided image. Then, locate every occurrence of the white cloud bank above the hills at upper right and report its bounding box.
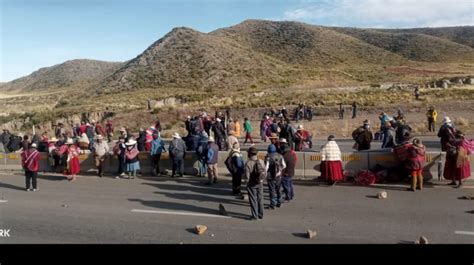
[283,0,474,27]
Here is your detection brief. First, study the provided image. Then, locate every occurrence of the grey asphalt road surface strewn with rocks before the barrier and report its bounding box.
[0,172,474,244]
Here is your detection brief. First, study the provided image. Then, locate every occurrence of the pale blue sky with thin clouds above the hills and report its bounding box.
[0,0,474,82]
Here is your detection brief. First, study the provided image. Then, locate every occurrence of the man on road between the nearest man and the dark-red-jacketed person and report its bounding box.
[265,144,286,210]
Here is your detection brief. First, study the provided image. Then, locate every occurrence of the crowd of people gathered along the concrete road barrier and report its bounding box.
[8,106,474,219]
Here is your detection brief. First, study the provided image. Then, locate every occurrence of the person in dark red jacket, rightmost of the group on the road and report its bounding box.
[281,142,298,202]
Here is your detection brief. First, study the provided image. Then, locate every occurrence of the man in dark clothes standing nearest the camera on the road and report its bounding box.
[245,146,267,220]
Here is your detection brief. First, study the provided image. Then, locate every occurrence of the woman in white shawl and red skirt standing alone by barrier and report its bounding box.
[321,135,344,186]
